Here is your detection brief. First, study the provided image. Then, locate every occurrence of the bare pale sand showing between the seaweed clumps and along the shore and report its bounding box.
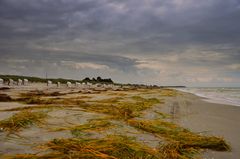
[0,84,240,159]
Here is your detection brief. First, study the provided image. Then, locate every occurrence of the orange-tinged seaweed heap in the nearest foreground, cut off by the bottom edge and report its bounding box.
[9,135,159,159]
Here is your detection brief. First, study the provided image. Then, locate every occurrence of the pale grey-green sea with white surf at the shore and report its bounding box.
[178,87,240,106]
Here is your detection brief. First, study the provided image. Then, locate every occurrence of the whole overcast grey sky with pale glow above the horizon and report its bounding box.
[0,0,240,86]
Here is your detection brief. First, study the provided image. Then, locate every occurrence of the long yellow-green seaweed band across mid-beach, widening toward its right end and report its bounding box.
[12,93,161,119]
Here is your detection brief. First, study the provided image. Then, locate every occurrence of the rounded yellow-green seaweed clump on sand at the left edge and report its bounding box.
[0,110,47,132]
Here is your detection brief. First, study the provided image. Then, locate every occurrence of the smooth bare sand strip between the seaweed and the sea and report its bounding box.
[159,93,240,159]
